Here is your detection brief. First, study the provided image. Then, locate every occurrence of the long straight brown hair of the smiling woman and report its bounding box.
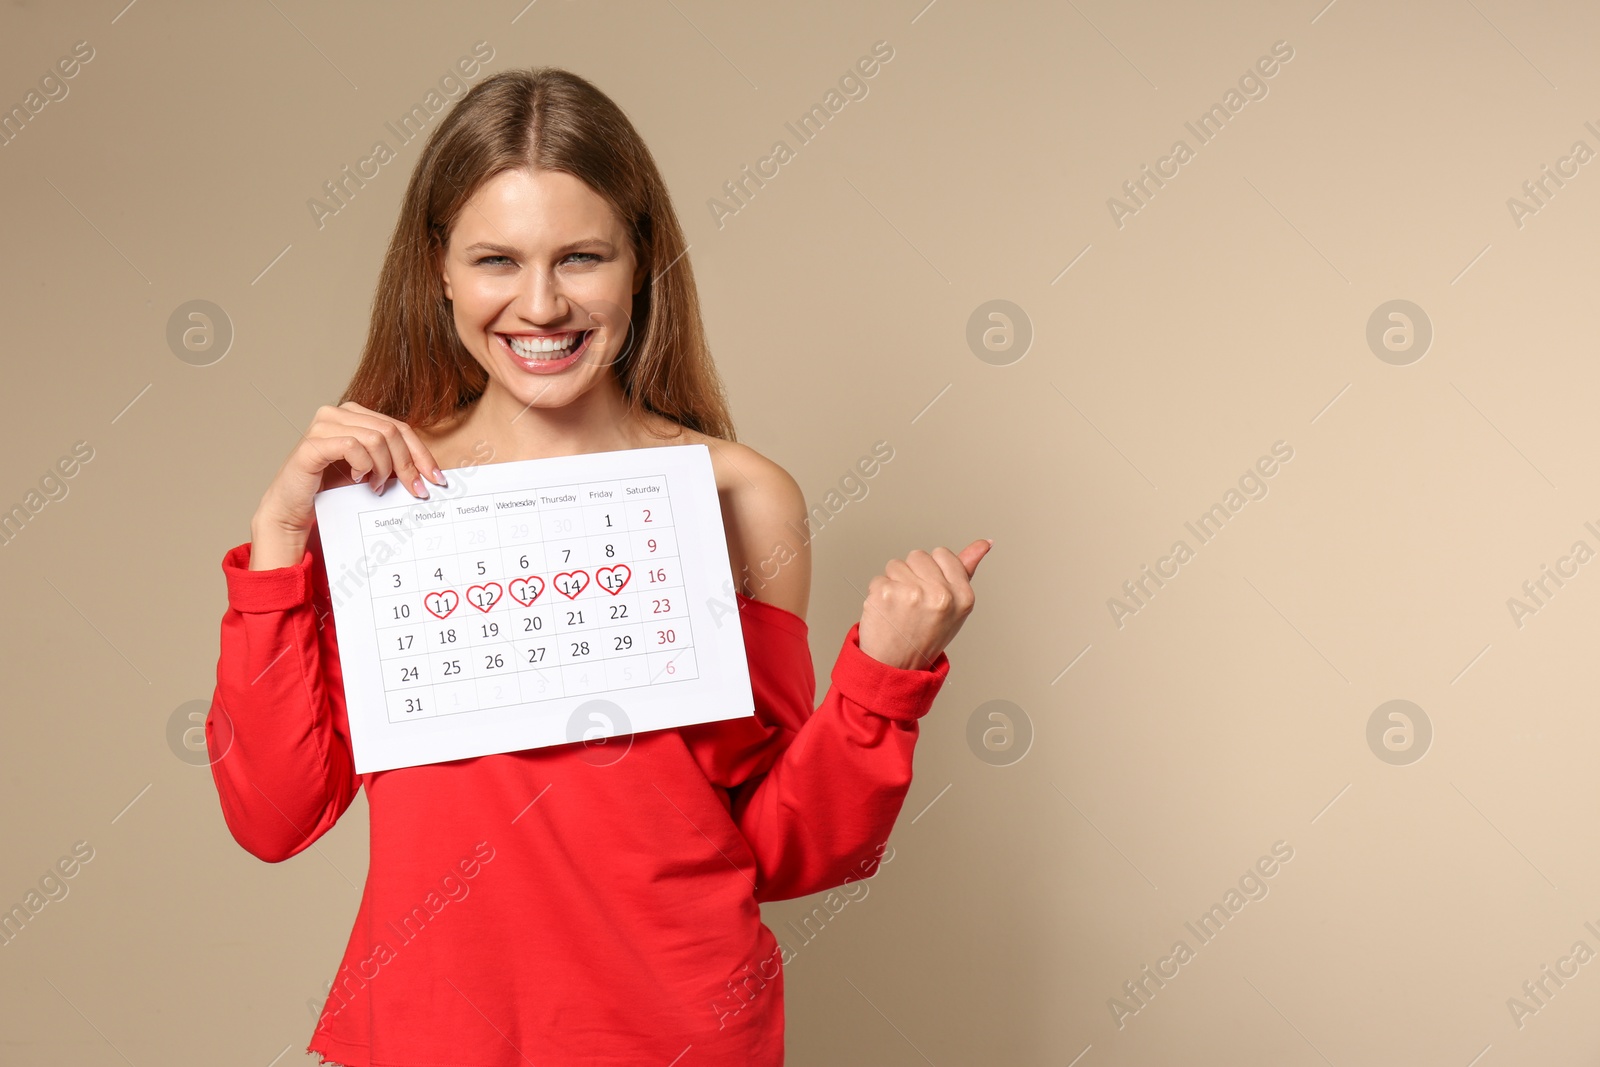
[341,67,736,440]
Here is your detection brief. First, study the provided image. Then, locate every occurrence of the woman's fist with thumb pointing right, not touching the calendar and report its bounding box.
[856,539,994,670]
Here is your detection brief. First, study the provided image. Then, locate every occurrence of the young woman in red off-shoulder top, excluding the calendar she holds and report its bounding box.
[206,69,990,1067]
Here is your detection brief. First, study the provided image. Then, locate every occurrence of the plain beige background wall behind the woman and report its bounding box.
[0,0,1600,1067]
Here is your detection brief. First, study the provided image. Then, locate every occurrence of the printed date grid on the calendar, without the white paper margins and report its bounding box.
[358,475,699,723]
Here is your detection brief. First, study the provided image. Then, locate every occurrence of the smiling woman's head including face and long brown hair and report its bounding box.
[344,72,733,454]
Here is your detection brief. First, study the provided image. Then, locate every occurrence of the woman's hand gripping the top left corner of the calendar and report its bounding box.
[250,402,445,571]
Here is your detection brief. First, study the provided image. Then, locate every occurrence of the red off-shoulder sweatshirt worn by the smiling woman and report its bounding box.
[206,534,950,1067]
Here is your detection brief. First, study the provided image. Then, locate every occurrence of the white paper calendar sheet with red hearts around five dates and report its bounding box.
[315,445,755,774]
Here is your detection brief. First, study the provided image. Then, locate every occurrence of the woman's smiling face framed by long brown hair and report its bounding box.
[440,170,645,408]
